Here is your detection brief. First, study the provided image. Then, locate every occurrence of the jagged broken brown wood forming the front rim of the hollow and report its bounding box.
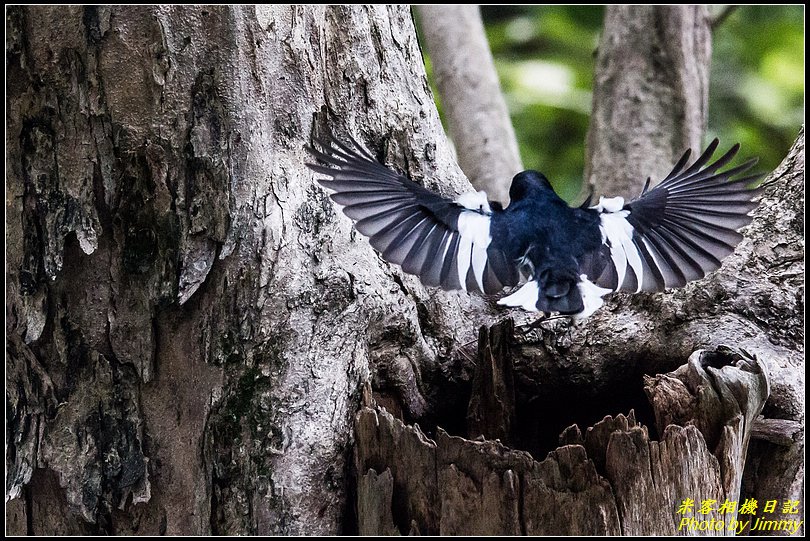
[355,348,768,535]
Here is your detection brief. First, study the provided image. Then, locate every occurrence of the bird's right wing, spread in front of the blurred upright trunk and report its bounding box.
[583,139,761,292]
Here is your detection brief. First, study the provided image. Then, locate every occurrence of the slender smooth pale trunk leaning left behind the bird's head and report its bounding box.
[416,5,523,206]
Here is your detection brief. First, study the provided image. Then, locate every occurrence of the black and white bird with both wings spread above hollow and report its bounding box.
[308,133,761,318]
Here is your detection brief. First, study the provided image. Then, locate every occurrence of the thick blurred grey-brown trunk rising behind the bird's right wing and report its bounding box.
[585,6,711,197]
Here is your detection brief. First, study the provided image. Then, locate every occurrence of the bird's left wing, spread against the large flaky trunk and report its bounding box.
[307,137,519,294]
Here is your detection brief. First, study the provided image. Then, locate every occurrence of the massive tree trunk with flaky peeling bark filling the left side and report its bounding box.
[6,6,486,535]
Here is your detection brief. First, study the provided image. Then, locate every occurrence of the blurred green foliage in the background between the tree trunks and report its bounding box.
[420,5,804,201]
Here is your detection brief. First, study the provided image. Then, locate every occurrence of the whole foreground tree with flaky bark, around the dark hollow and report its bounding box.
[6,6,804,535]
